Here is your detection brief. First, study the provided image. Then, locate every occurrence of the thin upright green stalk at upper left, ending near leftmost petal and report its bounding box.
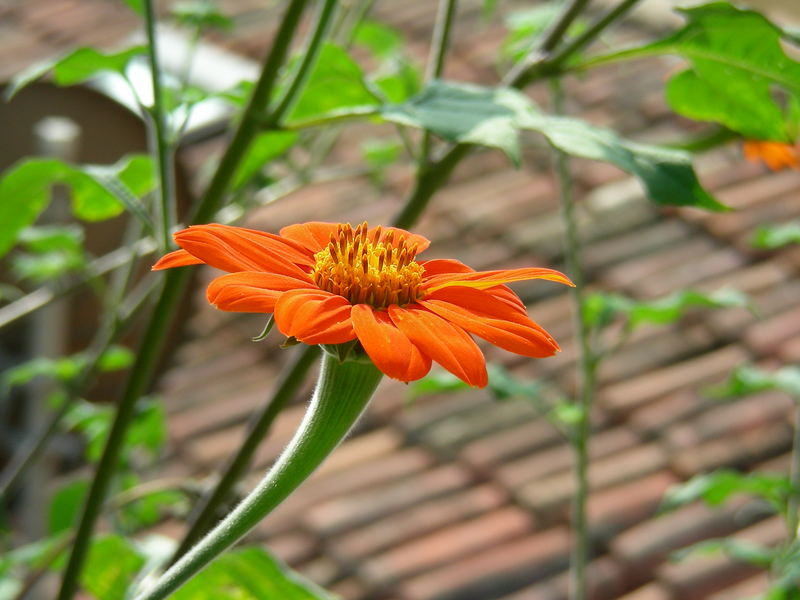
[142,0,175,252]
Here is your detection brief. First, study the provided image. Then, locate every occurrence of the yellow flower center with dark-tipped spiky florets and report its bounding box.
[311,223,425,309]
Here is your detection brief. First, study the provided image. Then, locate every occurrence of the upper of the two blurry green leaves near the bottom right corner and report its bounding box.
[660,469,792,513]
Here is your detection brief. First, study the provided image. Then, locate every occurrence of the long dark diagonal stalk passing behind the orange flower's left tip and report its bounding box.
[58,0,307,600]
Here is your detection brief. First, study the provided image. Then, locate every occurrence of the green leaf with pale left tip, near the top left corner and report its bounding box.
[6,46,147,100]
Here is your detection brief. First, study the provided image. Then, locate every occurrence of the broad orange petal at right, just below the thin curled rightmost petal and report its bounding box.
[419,288,559,358]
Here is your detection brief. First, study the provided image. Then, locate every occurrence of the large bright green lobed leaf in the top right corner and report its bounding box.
[586,2,800,142]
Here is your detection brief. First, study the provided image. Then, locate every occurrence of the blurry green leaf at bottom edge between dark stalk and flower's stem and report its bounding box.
[81,535,145,600]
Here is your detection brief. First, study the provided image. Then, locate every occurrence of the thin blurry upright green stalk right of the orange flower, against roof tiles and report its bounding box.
[551,79,597,600]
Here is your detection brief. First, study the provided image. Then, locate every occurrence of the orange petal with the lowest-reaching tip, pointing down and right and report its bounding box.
[389,305,488,387]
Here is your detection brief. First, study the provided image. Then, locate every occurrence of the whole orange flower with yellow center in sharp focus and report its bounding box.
[153,222,572,387]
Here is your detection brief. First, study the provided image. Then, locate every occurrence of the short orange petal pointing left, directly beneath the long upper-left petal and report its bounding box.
[206,271,316,313]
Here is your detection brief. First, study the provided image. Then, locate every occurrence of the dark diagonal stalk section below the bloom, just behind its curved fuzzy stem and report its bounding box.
[169,346,320,565]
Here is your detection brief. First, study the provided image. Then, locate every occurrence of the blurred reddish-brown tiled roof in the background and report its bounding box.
[0,0,800,600]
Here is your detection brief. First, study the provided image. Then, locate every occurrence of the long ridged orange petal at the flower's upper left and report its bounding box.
[174,224,311,277]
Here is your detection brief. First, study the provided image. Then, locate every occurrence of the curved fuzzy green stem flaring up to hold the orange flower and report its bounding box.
[136,353,382,600]
